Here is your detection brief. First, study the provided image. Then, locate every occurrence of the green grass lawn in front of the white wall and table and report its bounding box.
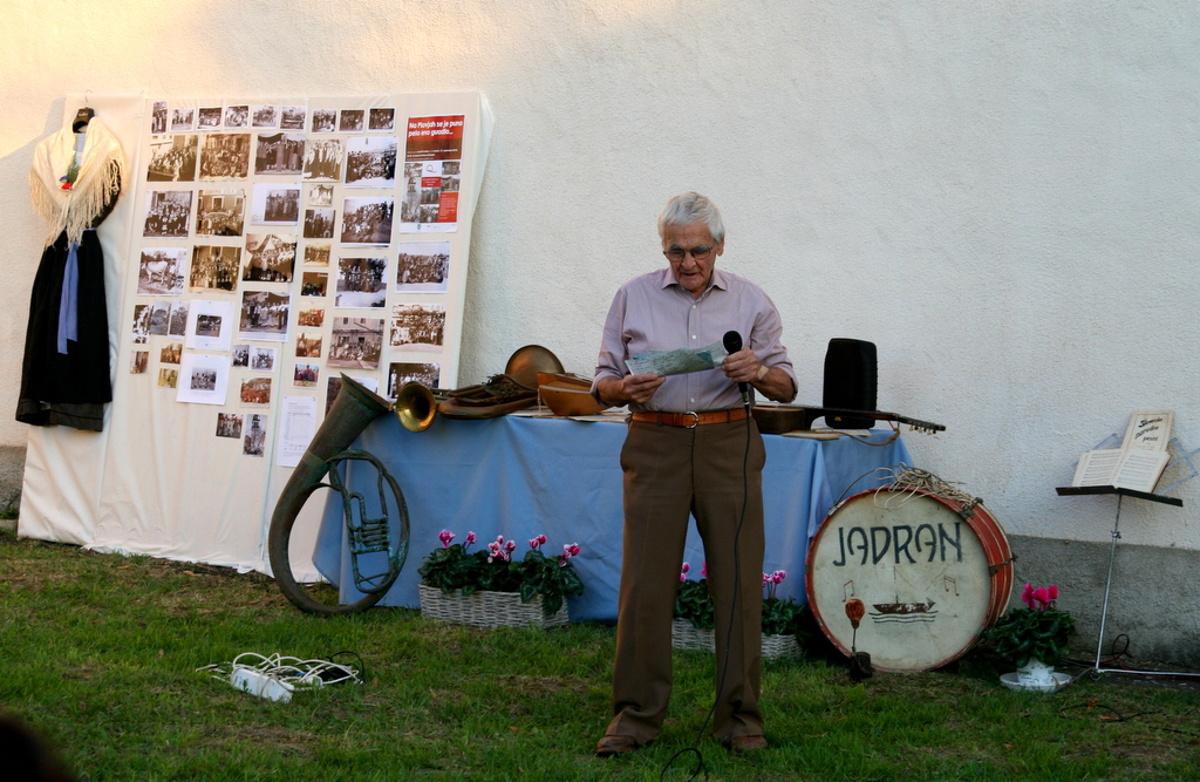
[0,531,1200,782]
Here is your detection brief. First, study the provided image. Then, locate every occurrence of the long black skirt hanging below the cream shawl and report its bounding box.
[17,230,113,432]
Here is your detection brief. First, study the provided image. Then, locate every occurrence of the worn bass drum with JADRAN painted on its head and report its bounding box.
[805,487,1013,673]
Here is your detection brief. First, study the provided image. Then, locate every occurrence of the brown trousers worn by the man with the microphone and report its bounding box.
[607,420,766,744]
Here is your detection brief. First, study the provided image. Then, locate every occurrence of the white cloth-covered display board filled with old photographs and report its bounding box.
[22,94,491,572]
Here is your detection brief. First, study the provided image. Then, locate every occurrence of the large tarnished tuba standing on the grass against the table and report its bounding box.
[266,374,408,614]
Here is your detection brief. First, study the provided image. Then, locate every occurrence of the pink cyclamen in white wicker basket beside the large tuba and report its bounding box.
[416,529,583,627]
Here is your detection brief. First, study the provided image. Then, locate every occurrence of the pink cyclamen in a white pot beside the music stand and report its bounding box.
[984,584,1075,690]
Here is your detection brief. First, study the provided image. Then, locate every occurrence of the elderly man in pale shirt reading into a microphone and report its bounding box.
[592,192,796,757]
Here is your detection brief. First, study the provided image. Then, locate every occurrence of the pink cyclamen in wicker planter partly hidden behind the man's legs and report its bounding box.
[672,563,808,657]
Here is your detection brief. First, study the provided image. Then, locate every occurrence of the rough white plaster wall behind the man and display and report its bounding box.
[0,0,1200,549]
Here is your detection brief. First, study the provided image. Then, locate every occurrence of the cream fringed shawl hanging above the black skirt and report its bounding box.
[29,118,125,247]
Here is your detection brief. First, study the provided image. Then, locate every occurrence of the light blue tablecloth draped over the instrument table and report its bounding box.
[313,415,911,621]
